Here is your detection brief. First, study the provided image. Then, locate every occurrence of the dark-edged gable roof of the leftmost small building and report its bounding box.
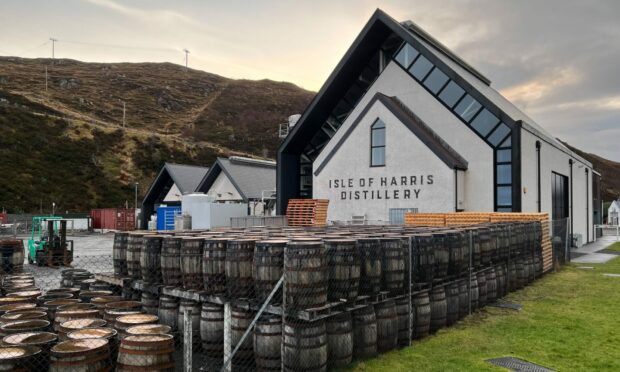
[144,163,209,202]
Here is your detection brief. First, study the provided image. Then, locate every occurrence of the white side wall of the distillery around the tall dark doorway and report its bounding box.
[521,129,594,243]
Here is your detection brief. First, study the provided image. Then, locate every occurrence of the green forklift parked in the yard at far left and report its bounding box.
[28,216,73,267]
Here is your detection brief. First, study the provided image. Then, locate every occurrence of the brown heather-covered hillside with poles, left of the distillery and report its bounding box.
[0,57,313,212]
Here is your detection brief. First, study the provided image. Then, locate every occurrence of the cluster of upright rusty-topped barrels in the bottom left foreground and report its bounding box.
[0,274,175,372]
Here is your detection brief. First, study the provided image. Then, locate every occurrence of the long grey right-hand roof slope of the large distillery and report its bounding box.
[401,21,592,167]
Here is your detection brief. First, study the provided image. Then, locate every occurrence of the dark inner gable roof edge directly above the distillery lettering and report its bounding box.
[314,93,467,176]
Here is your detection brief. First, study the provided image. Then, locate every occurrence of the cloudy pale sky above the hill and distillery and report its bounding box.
[0,0,620,161]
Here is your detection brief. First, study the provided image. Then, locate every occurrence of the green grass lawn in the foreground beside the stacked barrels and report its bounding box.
[349,258,620,372]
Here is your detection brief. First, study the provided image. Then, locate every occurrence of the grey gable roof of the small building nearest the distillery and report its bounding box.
[197,156,276,201]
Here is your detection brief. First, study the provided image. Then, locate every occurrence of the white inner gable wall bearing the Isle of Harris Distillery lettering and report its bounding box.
[313,101,455,222]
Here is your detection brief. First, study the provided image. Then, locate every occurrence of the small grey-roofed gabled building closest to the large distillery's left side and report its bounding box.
[197,156,276,216]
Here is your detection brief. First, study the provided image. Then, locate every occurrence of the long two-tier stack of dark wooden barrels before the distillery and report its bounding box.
[105,222,542,371]
